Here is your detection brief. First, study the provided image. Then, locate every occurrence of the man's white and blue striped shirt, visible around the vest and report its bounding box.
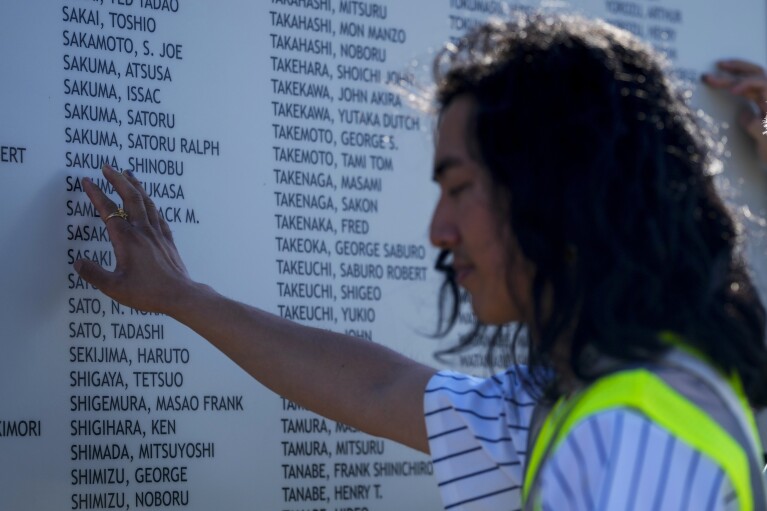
[424,368,738,511]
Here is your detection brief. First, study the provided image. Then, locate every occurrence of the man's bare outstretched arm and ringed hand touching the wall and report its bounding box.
[75,166,435,452]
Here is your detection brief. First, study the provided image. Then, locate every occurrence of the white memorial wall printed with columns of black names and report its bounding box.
[0,0,767,511]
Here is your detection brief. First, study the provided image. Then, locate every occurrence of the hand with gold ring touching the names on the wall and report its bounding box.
[74,165,194,314]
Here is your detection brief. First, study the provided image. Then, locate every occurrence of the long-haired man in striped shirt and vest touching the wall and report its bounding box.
[75,15,767,510]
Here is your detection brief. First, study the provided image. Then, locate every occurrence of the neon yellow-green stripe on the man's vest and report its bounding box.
[522,369,754,511]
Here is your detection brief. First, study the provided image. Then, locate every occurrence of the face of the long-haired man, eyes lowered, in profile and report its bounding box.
[430,96,533,324]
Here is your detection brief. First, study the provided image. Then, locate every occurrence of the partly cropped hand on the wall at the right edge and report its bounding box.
[703,59,767,162]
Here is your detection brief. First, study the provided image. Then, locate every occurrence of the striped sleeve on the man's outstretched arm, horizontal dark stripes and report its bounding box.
[424,369,535,511]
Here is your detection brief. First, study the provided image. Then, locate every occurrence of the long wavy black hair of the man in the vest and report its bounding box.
[435,14,767,407]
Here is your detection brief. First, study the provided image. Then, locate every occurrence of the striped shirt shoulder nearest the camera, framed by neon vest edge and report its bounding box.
[540,409,738,511]
